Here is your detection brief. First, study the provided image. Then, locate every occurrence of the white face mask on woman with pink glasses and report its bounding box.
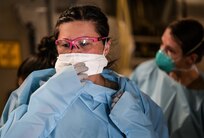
[55,53,108,76]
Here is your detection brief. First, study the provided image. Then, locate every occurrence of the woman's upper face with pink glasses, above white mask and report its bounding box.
[57,21,109,55]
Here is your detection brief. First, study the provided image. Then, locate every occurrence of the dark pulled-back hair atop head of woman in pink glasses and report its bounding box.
[54,5,109,39]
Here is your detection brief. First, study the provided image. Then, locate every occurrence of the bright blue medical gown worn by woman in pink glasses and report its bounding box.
[0,66,168,138]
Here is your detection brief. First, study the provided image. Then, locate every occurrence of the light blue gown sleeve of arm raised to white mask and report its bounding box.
[1,66,82,138]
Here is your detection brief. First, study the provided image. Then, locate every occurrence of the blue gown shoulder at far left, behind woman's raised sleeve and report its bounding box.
[0,68,55,127]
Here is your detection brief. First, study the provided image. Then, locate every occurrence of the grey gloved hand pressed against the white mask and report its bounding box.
[74,62,88,83]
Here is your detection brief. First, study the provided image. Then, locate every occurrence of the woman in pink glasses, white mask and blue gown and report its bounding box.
[0,5,168,138]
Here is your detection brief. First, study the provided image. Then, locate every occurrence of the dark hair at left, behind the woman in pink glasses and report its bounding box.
[17,36,58,86]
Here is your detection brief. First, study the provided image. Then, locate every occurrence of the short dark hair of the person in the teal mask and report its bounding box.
[168,19,204,63]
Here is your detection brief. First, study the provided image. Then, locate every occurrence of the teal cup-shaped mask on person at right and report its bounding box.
[156,50,176,73]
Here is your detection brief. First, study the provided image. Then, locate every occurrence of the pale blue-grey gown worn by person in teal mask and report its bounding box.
[130,60,204,138]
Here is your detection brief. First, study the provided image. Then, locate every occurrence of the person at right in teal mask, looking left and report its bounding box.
[130,18,204,138]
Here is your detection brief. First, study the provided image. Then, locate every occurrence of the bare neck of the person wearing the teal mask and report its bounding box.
[168,68,199,86]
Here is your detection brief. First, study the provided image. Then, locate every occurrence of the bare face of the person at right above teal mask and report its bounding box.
[160,28,190,68]
